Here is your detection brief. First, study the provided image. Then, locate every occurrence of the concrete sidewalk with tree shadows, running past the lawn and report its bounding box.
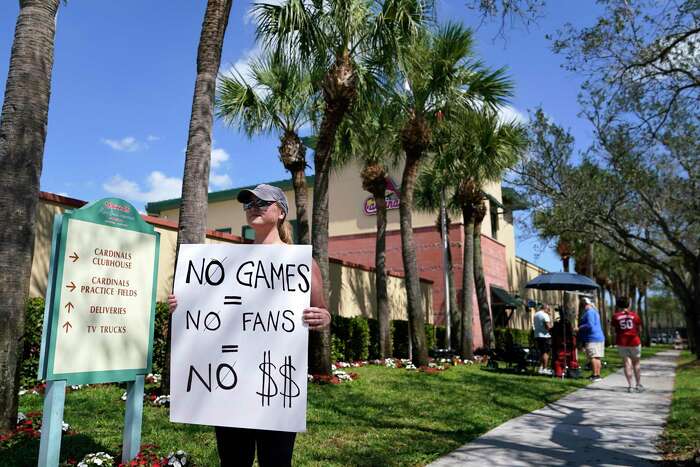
[429,350,679,467]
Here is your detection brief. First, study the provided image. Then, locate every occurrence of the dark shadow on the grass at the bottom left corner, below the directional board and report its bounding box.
[0,434,112,467]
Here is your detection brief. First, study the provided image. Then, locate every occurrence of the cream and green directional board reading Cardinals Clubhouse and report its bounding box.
[39,198,159,384]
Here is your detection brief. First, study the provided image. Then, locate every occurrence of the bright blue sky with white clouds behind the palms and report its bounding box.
[0,0,596,271]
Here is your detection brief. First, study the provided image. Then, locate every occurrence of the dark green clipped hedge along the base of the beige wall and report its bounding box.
[19,298,448,387]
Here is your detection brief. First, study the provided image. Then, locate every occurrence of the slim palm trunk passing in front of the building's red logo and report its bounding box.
[373,183,393,358]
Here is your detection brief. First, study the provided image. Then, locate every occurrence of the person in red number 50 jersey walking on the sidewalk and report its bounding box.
[612,297,644,392]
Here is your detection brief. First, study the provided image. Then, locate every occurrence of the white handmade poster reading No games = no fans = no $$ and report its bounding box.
[170,245,311,432]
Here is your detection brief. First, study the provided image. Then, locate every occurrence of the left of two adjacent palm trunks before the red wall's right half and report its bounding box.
[460,204,474,358]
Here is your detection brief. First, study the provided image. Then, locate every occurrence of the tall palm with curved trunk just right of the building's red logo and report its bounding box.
[393,23,511,365]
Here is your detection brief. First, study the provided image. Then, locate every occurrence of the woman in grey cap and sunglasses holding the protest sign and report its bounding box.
[168,184,331,467]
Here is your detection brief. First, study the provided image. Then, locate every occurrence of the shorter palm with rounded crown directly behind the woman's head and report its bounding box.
[217,53,315,244]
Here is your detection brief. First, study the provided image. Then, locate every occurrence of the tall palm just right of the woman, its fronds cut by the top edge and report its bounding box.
[253,0,428,374]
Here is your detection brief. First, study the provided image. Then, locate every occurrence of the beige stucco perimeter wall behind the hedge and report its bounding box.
[29,199,433,322]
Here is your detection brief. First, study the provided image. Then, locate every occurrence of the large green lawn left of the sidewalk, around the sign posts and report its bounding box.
[0,347,663,467]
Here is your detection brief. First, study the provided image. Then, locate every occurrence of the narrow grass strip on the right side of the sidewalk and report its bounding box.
[661,351,700,465]
